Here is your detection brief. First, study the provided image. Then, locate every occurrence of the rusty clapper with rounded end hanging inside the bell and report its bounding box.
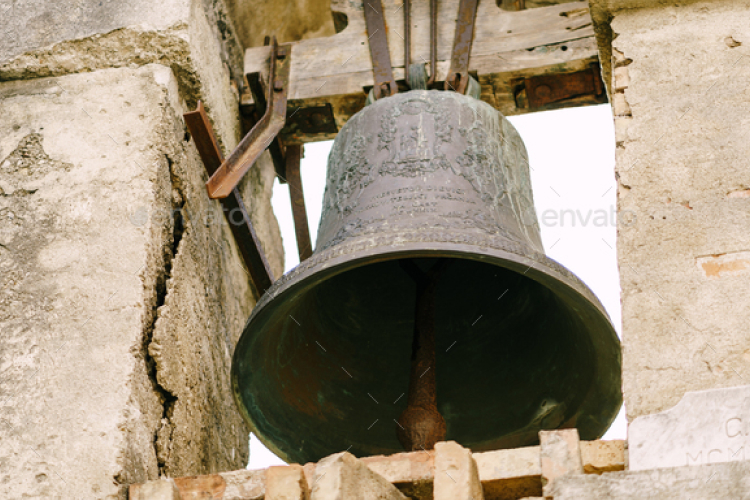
[396,259,449,451]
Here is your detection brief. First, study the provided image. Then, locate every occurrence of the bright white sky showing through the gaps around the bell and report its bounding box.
[248,104,626,469]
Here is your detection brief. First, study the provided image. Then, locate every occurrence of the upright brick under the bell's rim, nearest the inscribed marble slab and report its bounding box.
[539,429,583,498]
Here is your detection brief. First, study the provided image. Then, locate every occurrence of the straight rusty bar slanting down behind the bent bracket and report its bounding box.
[183,101,274,295]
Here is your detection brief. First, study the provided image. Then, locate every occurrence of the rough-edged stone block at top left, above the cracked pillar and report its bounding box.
[0,0,243,148]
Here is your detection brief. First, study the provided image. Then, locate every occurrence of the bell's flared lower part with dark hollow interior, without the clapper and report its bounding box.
[232,234,622,463]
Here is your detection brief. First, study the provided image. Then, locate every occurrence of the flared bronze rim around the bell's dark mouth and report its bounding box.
[230,231,623,463]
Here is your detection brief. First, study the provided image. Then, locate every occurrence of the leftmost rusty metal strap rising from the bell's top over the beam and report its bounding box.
[364,0,398,99]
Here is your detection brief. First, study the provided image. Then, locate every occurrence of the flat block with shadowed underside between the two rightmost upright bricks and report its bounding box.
[473,446,542,500]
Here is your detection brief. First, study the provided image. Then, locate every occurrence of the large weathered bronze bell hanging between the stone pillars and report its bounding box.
[232,90,622,463]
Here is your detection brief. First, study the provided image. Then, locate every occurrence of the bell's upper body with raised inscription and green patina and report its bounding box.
[319,92,541,254]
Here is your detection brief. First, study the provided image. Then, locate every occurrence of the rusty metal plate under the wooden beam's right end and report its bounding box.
[524,63,607,109]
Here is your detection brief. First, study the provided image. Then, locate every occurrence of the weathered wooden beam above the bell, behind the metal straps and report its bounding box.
[242,0,602,144]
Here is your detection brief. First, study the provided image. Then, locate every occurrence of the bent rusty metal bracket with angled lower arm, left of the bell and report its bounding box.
[206,38,292,199]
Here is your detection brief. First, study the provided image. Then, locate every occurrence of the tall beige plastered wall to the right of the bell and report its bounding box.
[610,0,750,420]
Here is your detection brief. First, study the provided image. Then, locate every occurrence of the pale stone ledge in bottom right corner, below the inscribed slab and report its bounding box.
[551,461,750,500]
